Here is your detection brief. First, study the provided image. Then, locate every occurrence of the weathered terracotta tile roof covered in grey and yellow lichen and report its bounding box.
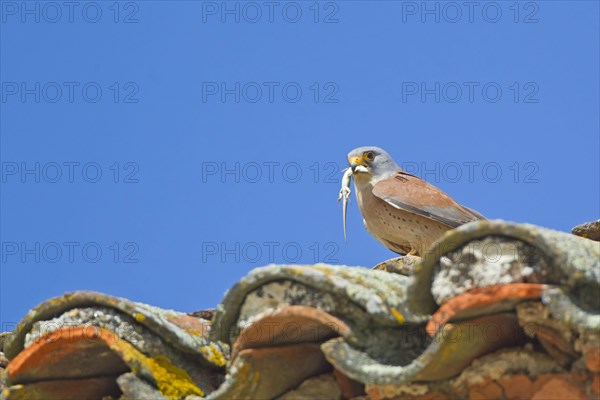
[0,221,600,400]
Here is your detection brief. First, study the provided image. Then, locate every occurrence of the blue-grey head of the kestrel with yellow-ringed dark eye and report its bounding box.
[348,146,400,180]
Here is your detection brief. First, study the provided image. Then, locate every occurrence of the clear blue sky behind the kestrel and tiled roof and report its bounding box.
[0,1,600,330]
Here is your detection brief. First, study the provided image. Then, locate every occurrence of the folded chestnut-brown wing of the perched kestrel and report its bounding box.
[373,171,485,228]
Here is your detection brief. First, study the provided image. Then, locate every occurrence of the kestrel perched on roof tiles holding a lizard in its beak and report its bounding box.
[339,146,486,257]
